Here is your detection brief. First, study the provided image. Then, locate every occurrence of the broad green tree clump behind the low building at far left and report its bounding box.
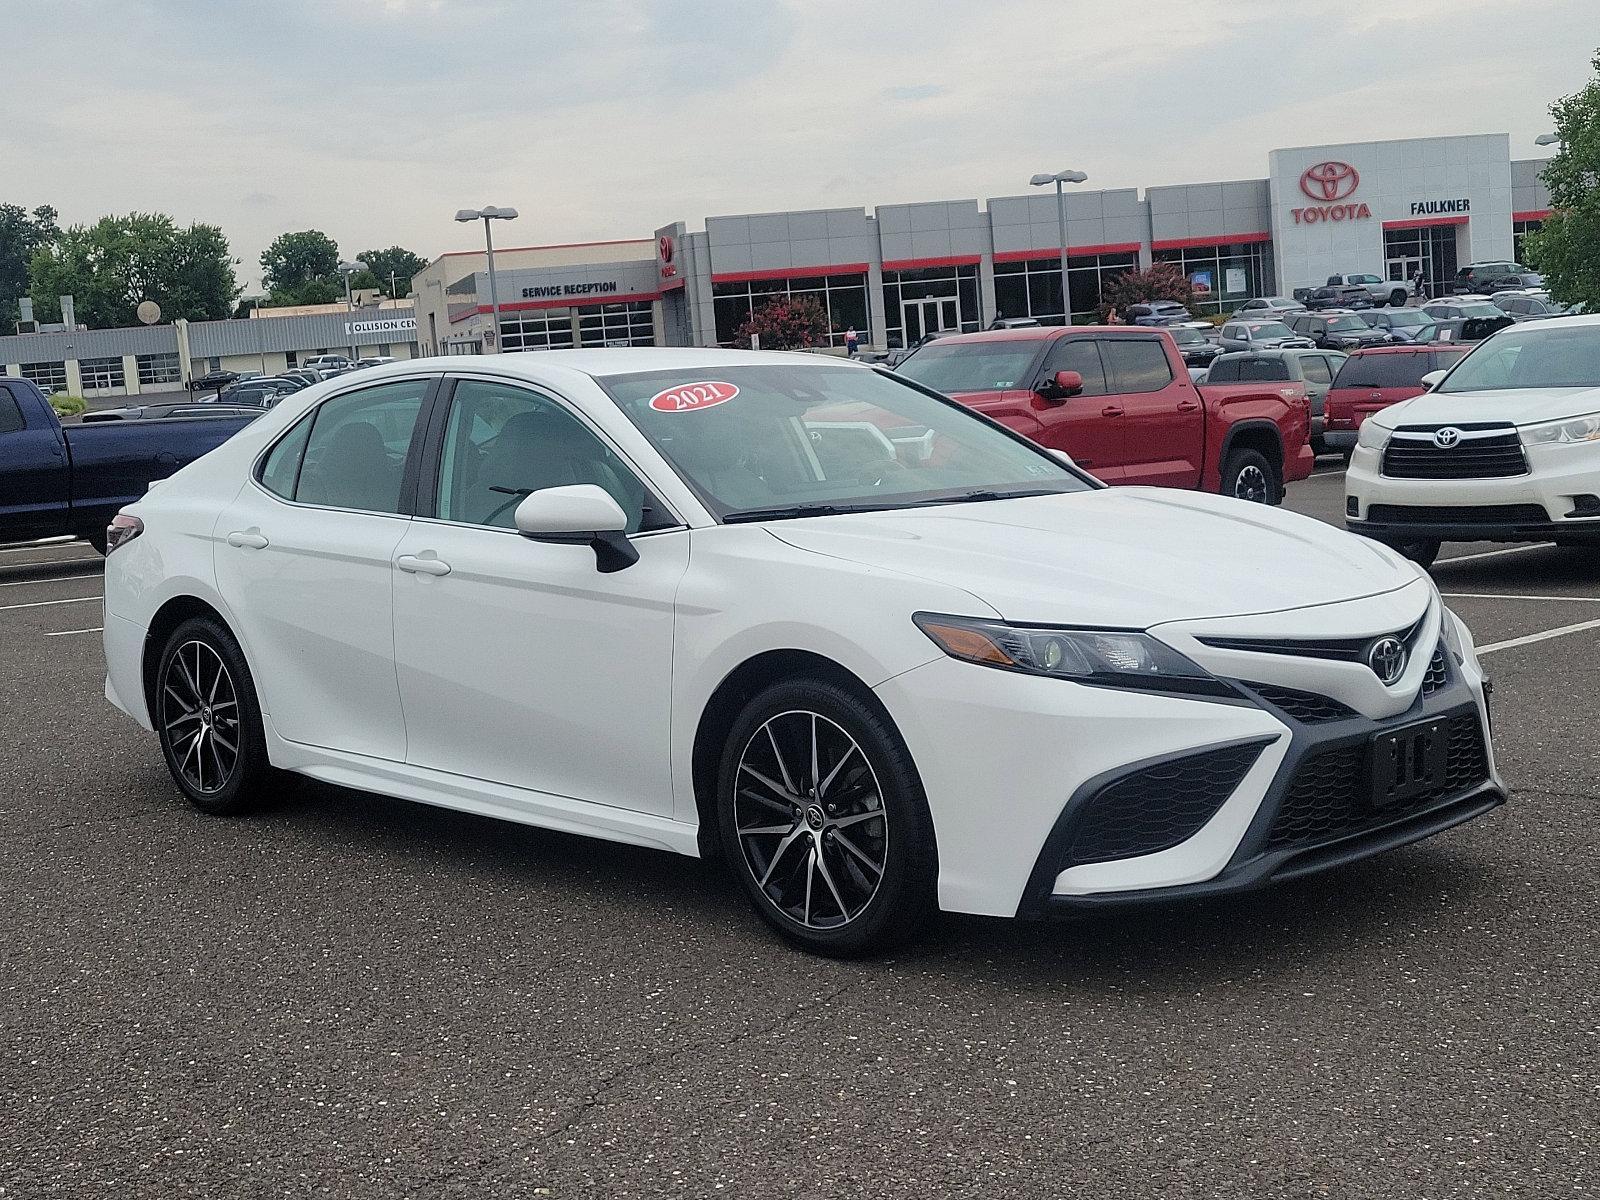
[29,213,238,330]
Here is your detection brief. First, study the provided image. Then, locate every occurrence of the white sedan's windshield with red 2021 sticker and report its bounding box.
[598,365,1093,522]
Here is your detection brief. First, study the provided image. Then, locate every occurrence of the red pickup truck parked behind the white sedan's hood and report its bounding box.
[896,325,1314,504]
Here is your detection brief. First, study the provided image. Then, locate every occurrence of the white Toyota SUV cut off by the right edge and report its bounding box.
[1344,315,1600,563]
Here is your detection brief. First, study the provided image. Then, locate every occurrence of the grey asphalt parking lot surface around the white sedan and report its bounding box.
[0,470,1600,1200]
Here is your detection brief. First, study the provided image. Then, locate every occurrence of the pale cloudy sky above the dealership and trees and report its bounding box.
[0,0,1600,285]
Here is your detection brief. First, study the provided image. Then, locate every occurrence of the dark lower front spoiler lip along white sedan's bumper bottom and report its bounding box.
[1016,781,1506,920]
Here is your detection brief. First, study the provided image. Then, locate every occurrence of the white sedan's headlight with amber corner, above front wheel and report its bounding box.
[912,613,1234,696]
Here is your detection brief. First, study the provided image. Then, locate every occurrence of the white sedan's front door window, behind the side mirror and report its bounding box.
[435,379,656,533]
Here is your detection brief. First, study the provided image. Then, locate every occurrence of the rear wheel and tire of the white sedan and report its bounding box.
[150,616,272,816]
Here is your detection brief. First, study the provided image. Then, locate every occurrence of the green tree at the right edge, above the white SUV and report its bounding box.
[1523,51,1600,312]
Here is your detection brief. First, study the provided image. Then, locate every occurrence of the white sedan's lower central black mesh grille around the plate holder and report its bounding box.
[1267,712,1490,850]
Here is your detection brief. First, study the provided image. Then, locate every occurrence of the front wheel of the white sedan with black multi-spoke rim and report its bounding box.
[717,678,938,957]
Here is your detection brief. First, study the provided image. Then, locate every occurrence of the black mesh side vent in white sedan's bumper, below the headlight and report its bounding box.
[1061,742,1266,867]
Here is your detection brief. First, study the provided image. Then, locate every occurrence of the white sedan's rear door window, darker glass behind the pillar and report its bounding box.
[286,379,432,512]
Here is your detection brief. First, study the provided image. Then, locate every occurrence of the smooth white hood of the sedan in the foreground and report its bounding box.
[768,488,1418,629]
